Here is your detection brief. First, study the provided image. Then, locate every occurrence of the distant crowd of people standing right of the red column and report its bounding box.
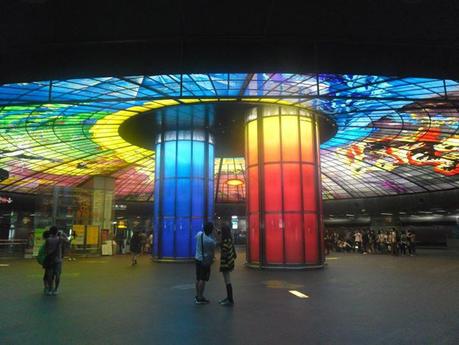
[324,228,416,256]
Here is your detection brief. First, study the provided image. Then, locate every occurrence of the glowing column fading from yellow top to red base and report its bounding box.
[245,106,324,268]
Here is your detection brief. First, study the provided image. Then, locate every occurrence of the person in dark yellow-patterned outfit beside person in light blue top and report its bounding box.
[218,224,236,306]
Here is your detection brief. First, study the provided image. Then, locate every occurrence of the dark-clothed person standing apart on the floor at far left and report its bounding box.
[43,226,69,296]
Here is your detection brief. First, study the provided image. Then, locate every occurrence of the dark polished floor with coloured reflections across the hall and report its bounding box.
[0,250,459,345]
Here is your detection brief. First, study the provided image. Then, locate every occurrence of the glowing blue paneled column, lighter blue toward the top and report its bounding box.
[153,130,214,261]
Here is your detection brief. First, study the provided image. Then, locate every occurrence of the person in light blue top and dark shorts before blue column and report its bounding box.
[195,223,216,304]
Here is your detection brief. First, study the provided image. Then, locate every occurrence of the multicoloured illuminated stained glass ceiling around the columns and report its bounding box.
[0,73,459,200]
